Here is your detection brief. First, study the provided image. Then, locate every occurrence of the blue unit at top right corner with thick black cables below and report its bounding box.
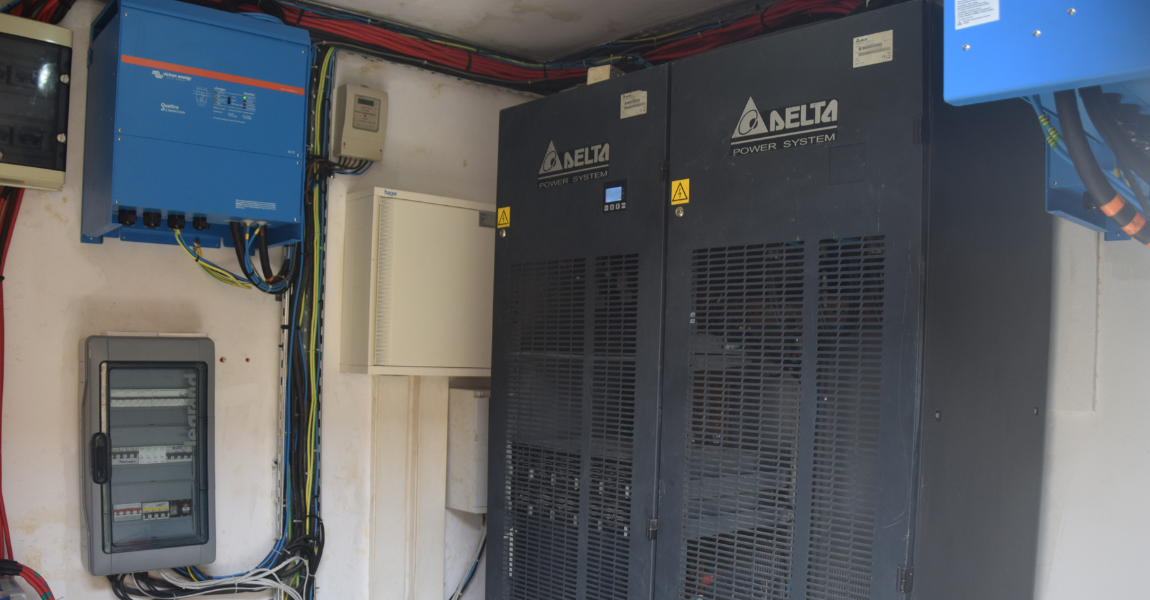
[943,0,1150,240]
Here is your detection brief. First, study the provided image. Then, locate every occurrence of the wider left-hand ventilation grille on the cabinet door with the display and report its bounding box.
[503,259,587,600]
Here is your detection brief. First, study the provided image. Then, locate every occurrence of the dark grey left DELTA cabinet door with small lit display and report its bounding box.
[486,68,668,600]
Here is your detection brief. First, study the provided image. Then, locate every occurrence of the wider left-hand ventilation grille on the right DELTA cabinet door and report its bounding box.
[680,243,804,600]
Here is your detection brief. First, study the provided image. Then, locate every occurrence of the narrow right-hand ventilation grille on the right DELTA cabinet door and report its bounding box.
[806,236,884,600]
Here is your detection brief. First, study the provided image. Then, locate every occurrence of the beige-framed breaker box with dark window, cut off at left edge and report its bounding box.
[0,14,71,190]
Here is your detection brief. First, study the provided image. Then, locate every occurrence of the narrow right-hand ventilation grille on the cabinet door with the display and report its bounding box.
[587,254,639,600]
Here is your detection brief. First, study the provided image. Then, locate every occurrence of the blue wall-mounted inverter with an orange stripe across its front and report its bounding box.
[81,0,311,247]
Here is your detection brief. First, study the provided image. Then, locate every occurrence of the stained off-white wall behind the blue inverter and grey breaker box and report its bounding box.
[3,0,529,600]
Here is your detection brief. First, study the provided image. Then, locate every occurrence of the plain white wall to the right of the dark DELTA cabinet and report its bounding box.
[1036,219,1150,600]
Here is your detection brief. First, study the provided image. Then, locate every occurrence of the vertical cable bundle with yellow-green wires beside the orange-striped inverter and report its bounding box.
[108,47,345,600]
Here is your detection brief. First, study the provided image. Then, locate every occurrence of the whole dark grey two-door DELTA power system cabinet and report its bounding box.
[488,1,1052,600]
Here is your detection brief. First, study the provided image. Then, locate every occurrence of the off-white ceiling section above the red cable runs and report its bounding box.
[310,0,739,60]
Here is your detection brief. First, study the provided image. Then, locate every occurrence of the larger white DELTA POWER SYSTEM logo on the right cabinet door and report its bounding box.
[730,98,838,156]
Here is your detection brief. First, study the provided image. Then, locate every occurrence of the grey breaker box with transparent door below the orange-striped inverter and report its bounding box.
[81,336,215,576]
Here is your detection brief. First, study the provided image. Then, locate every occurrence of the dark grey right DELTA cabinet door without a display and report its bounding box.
[656,2,925,600]
